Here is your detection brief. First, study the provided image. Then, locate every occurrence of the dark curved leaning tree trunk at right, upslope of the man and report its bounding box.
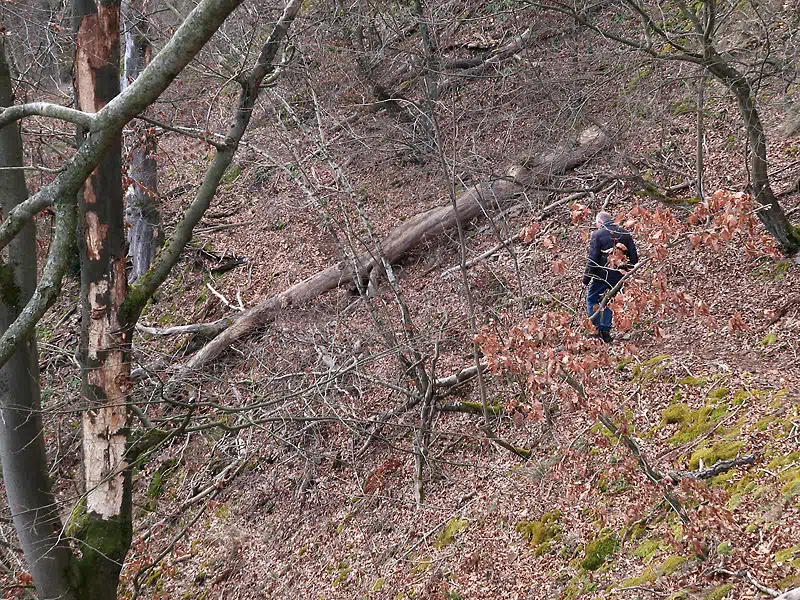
[706,53,800,255]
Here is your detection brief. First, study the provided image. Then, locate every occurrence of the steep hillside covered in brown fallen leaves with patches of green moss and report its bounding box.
[17,2,800,600]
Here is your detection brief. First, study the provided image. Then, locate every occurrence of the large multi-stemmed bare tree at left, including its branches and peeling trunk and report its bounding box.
[0,0,300,600]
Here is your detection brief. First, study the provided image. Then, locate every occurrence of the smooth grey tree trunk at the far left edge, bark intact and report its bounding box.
[0,34,74,599]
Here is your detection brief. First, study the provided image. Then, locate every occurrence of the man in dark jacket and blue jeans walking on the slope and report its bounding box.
[583,212,639,344]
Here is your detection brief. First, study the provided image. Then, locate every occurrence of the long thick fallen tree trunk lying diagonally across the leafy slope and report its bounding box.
[173,127,609,374]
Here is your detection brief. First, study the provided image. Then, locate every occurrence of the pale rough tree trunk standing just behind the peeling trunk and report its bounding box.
[121,0,164,283]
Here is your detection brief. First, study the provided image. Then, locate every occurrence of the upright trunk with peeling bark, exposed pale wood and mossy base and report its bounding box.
[74,0,132,600]
